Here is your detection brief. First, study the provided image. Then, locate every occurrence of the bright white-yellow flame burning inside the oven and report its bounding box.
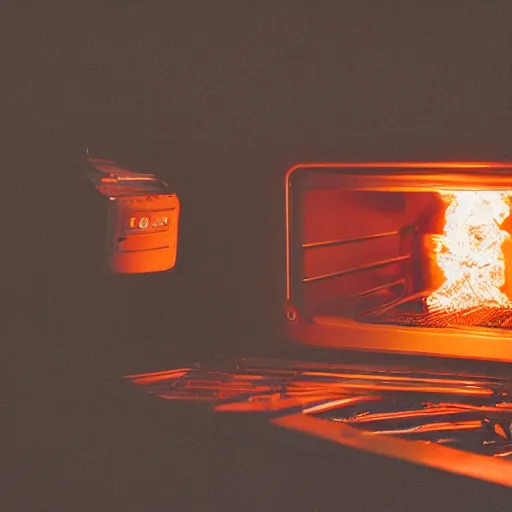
[427,190,512,311]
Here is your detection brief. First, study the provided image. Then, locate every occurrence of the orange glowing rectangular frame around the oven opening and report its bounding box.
[283,162,512,363]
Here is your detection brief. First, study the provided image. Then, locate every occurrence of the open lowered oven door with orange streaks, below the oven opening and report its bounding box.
[127,359,512,487]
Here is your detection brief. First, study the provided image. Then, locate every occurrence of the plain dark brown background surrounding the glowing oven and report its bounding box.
[6,0,512,511]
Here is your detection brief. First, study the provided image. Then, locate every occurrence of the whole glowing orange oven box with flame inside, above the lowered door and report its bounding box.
[284,162,512,362]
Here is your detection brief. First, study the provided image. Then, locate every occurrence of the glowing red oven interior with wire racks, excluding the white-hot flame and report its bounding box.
[292,170,512,331]
